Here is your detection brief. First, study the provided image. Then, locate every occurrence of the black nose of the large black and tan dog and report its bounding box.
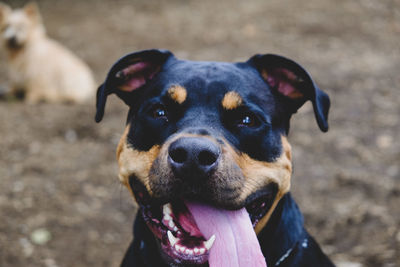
[168,137,221,179]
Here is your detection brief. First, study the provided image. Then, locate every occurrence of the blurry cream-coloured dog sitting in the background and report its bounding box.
[0,2,96,103]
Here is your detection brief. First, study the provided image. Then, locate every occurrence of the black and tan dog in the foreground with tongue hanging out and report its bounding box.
[95,49,334,267]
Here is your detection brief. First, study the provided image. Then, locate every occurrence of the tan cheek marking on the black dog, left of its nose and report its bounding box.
[117,125,160,195]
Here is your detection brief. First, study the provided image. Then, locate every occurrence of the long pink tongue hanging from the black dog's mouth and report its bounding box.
[185,202,267,267]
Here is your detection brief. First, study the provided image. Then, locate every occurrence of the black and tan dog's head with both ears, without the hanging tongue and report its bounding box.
[96,50,329,265]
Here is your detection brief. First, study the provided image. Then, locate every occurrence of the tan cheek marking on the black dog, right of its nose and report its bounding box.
[228,136,292,234]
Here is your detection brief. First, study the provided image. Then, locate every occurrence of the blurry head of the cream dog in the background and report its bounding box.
[0,2,44,50]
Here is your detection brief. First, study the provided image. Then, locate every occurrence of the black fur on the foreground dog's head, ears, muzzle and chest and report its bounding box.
[96,50,333,267]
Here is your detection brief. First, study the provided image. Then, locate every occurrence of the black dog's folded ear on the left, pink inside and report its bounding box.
[95,49,174,122]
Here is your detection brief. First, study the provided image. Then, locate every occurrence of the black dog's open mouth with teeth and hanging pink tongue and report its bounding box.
[135,180,275,266]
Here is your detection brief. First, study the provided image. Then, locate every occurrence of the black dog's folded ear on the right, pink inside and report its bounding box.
[247,54,330,132]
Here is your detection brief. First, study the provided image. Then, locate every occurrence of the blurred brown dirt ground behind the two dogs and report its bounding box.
[0,0,400,267]
